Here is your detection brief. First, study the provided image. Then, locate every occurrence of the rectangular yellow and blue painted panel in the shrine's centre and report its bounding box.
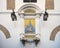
[24,19,35,33]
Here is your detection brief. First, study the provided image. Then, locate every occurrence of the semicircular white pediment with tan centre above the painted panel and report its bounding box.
[18,4,41,14]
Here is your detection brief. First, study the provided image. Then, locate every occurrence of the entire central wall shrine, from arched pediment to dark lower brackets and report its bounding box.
[18,4,41,45]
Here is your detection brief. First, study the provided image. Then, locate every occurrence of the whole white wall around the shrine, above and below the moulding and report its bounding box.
[0,0,60,48]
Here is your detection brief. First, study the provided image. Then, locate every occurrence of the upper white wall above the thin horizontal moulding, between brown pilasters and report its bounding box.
[0,0,60,13]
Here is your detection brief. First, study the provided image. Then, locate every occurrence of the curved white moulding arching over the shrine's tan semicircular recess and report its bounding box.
[18,4,41,13]
